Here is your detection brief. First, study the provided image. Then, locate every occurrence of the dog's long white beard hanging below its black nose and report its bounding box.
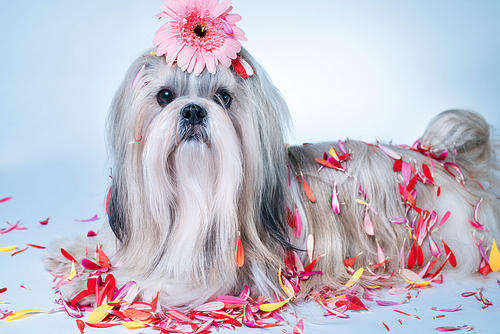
[138,106,243,298]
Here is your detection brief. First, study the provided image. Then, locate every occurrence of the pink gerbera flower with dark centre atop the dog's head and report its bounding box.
[153,0,246,75]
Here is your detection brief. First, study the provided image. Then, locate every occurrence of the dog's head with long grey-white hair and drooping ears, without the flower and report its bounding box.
[108,50,289,300]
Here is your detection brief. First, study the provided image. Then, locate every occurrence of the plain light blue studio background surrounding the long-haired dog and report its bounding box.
[0,0,500,333]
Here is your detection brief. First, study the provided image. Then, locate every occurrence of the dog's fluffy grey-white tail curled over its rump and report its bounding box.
[420,110,500,195]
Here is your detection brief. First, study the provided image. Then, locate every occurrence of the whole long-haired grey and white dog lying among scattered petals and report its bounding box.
[44,50,500,308]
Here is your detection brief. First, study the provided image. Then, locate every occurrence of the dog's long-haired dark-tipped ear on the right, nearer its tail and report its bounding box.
[235,48,291,248]
